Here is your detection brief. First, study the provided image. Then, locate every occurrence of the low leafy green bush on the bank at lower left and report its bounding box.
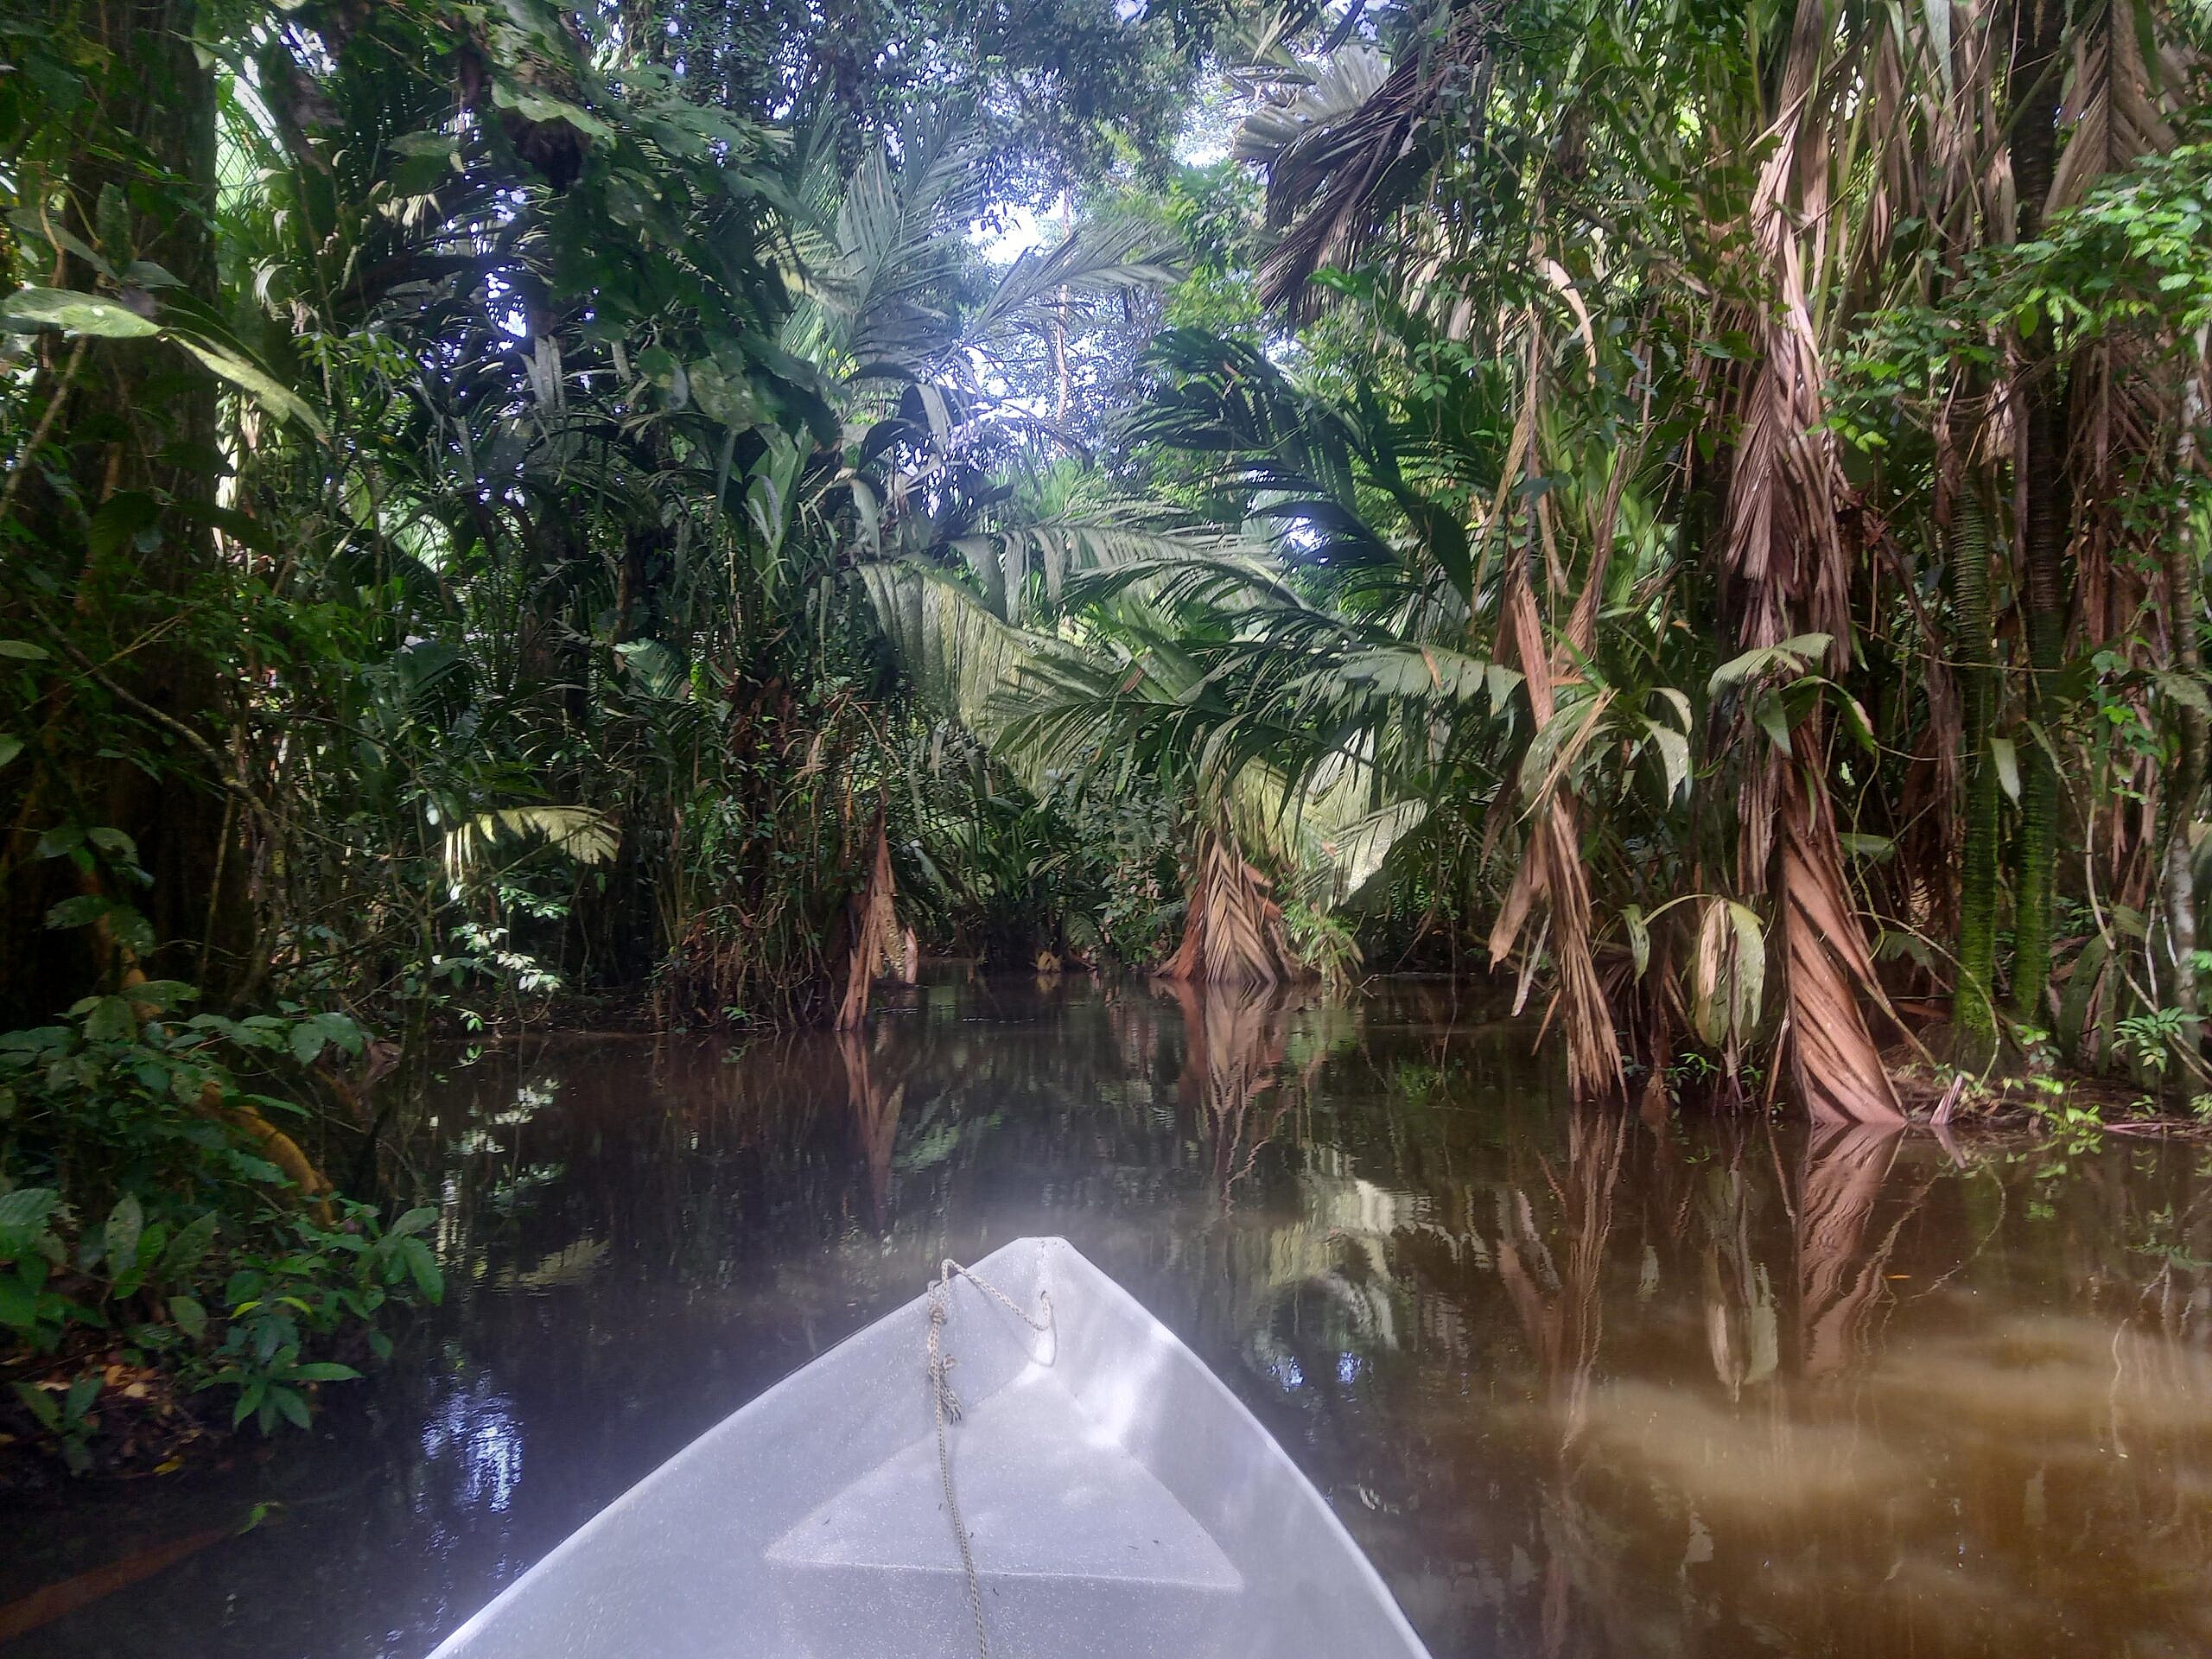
[0,982,442,1469]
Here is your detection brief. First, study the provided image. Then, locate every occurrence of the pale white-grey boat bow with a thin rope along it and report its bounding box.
[435,1239,1425,1659]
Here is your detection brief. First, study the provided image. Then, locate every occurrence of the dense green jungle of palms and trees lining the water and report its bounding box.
[0,0,2212,1462]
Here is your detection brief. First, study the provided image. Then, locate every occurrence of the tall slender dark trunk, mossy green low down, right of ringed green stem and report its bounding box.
[2006,0,2073,1027]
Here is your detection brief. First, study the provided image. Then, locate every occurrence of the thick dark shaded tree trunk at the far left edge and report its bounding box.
[0,0,250,1022]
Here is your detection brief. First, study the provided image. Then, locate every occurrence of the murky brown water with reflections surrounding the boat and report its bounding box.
[0,982,2212,1659]
